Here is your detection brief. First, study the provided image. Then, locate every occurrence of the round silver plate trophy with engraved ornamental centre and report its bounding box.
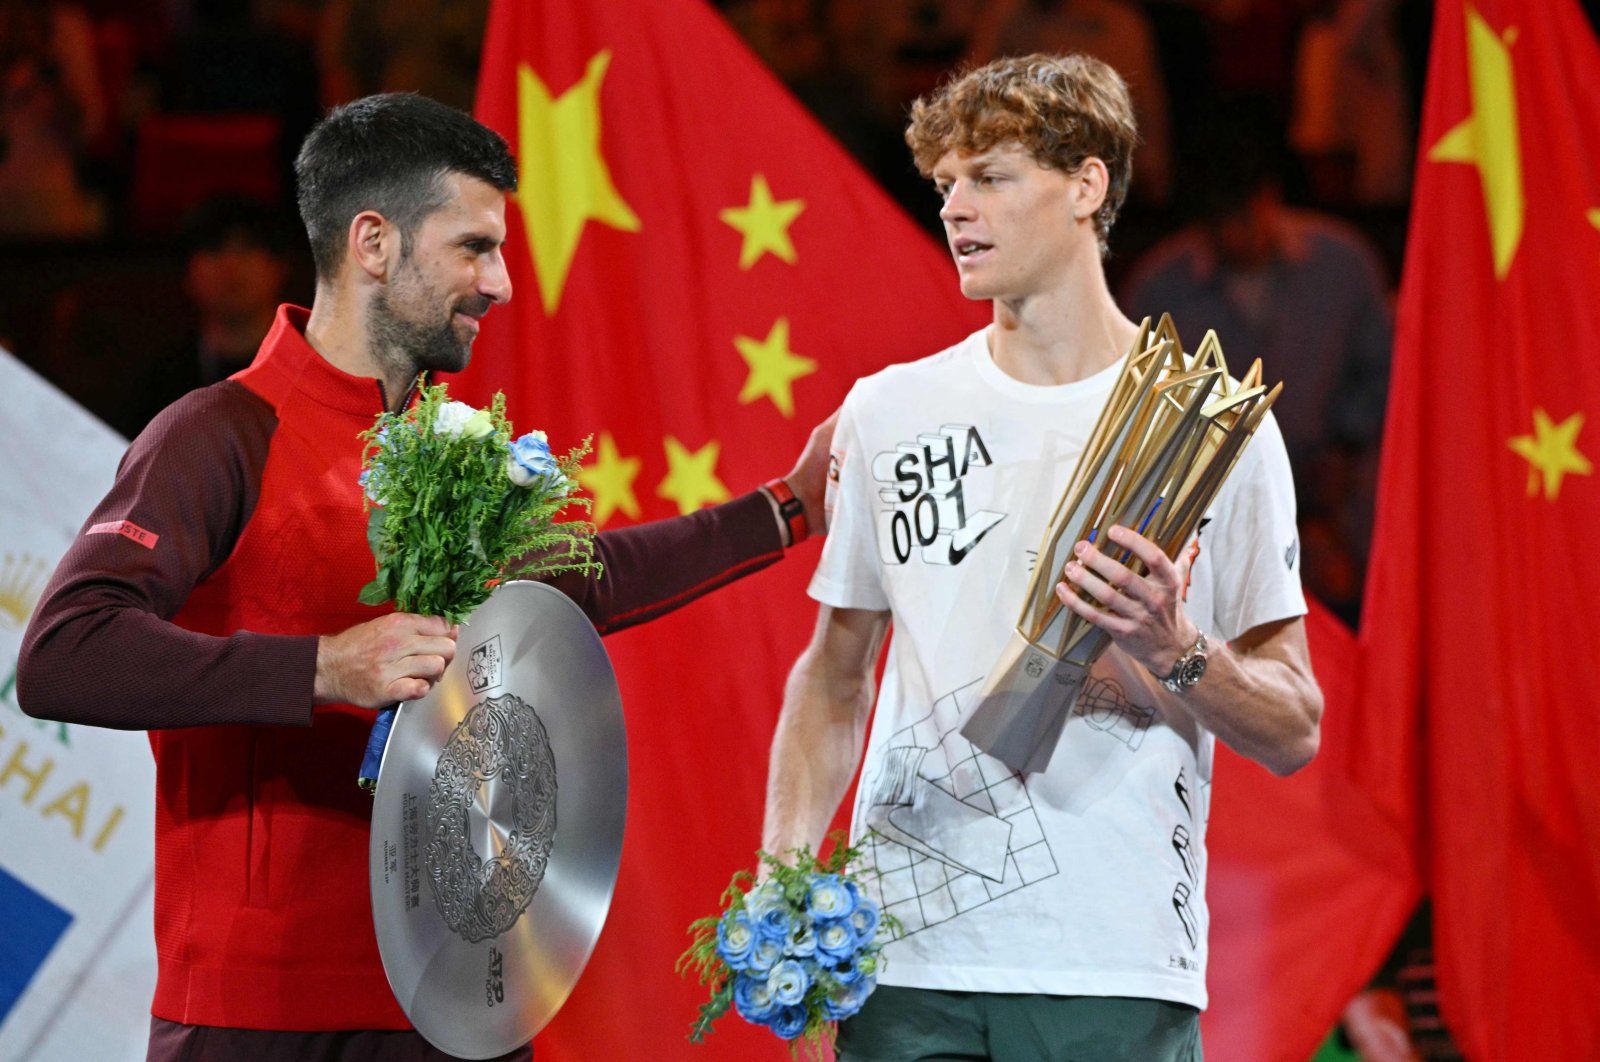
[370,582,627,1059]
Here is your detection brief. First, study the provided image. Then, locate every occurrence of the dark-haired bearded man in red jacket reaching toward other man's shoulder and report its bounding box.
[18,94,827,1062]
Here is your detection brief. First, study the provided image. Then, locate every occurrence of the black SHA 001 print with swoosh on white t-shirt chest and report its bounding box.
[872,424,1005,566]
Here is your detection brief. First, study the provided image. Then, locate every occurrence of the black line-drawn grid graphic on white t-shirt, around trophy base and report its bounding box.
[862,680,1155,934]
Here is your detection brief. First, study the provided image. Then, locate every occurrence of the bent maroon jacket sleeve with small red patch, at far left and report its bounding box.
[16,382,317,729]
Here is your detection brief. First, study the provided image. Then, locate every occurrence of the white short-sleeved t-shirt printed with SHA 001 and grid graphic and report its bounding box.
[810,329,1306,1008]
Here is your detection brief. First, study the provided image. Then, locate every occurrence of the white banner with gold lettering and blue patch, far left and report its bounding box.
[0,350,155,1062]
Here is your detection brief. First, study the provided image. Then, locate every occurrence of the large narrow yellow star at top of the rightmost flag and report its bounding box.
[1427,3,1525,280]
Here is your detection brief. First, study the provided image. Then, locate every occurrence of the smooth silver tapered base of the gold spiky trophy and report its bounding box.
[962,632,1088,774]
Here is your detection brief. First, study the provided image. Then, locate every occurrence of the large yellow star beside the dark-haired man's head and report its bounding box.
[517,51,638,313]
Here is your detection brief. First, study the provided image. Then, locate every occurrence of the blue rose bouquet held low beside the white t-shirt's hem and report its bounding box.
[678,833,896,1049]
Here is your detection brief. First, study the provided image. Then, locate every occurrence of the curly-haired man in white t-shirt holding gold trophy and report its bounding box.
[763,56,1322,1062]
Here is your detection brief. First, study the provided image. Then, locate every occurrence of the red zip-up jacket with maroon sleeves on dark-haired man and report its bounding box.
[18,307,782,1030]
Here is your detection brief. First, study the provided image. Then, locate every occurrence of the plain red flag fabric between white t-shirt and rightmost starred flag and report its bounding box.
[1202,601,1419,1062]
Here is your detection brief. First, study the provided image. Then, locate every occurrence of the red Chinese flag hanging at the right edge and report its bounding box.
[1350,0,1600,1062]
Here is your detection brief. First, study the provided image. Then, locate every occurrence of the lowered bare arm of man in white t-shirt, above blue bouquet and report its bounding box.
[762,605,890,854]
